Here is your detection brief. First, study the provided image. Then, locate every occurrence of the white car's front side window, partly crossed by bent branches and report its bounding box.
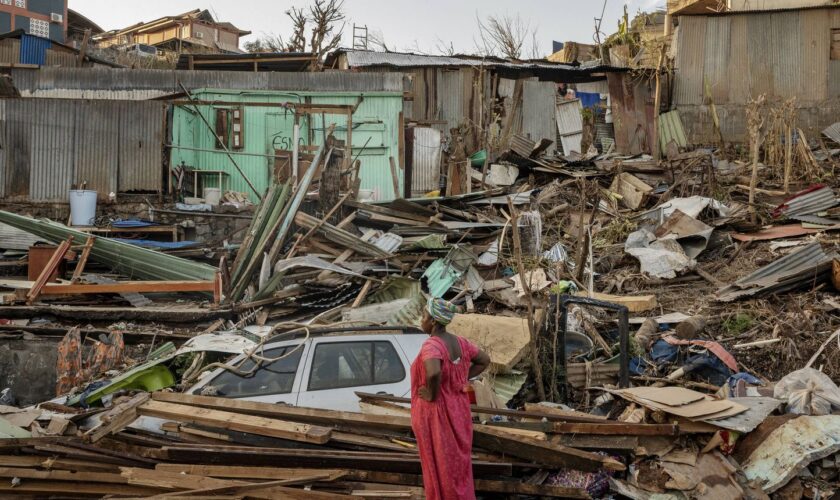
[197,346,303,398]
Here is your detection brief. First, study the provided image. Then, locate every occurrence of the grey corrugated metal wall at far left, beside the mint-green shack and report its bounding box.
[0,99,164,201]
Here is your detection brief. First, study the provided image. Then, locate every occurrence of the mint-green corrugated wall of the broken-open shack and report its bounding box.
[170,89,403,201]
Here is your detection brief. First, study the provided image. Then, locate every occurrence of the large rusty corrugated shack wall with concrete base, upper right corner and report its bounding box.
[672,8,840,144]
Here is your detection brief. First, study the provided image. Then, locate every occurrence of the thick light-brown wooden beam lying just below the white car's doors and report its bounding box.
[138,400,331,444]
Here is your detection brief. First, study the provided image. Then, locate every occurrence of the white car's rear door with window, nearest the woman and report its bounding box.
[297,336,410,412]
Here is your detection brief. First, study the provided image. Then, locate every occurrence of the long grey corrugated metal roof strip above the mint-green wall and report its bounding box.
[11,68,403,99]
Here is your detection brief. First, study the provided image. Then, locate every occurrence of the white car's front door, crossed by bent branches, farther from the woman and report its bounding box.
[191,343,307,405]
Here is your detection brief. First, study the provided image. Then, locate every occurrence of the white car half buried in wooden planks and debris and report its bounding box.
[186,327,429,412]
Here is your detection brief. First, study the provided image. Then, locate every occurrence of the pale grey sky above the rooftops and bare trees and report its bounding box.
[69,0,665,56]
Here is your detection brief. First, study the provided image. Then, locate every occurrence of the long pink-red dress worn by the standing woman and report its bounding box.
[411,337,478,500]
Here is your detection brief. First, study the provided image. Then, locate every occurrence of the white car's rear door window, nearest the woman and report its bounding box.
[309,342,405,391]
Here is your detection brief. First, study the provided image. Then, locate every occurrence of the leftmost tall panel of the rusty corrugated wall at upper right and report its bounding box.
[674,16,707,105]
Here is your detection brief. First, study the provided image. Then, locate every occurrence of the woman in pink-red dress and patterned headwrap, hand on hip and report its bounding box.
[411,299,490,500]
